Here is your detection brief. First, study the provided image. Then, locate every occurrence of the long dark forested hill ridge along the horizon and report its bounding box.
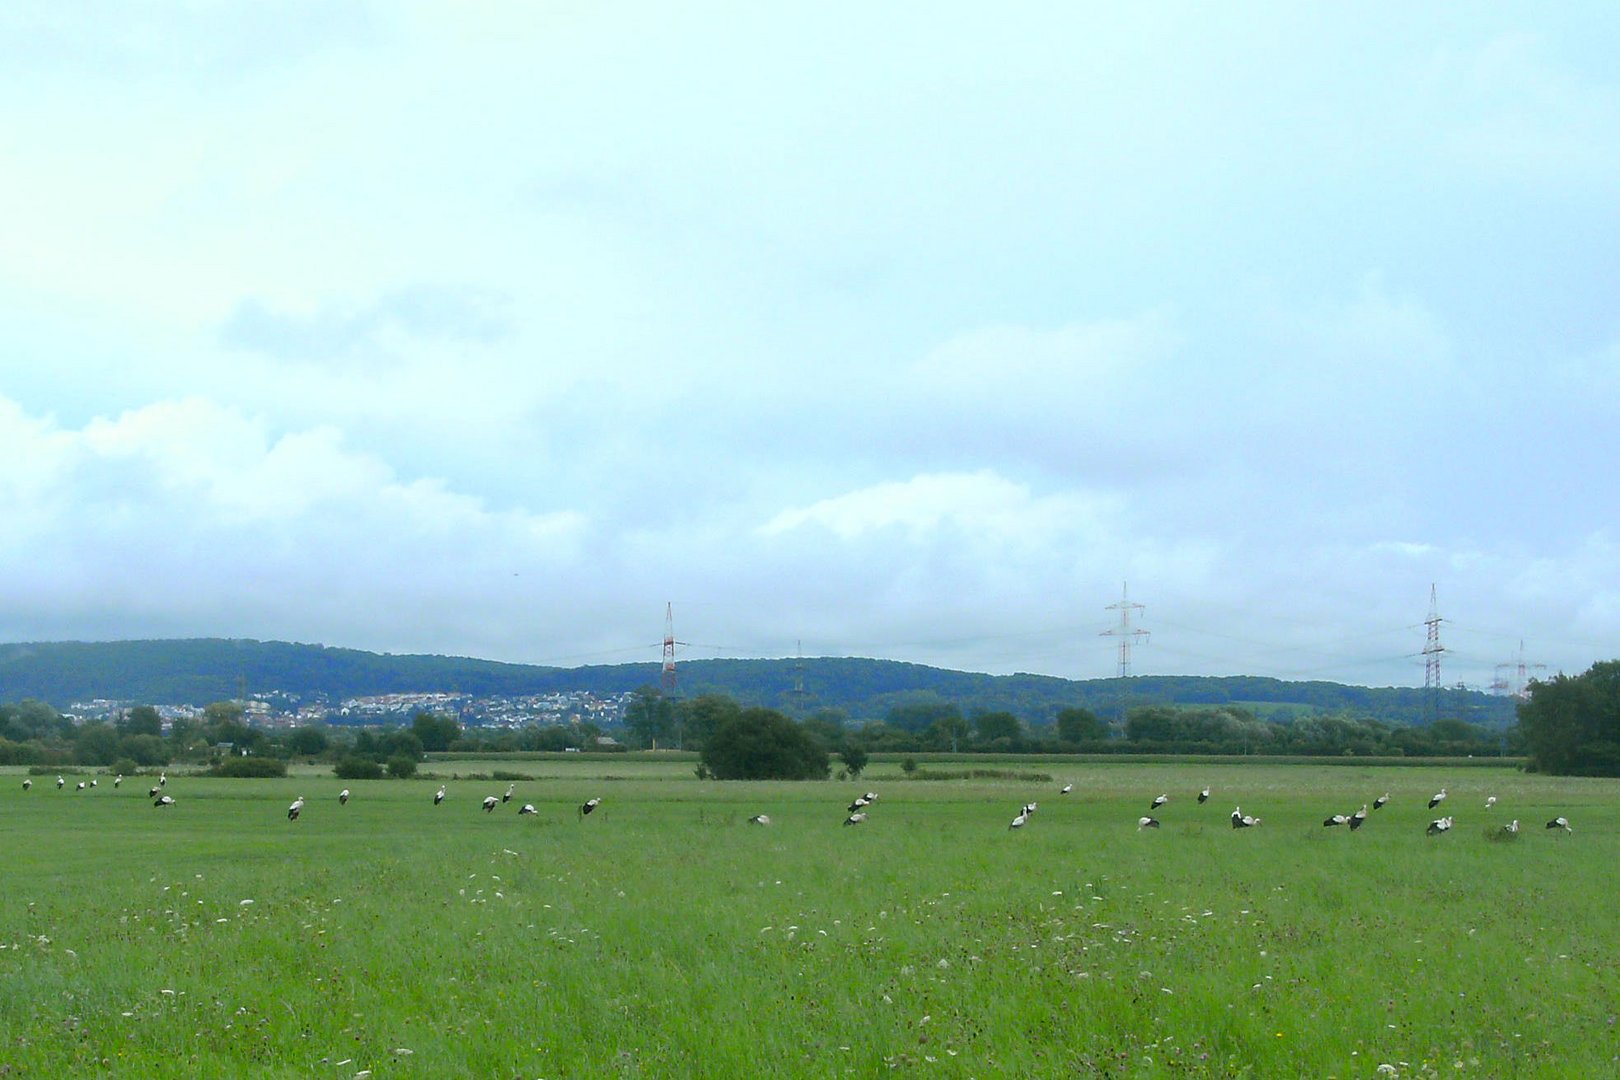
[0,638,1513,727]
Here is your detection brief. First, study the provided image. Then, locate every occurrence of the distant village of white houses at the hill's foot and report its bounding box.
[65,690,632,732]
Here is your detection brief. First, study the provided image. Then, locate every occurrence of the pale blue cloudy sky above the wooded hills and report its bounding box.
[0,0,1620,690]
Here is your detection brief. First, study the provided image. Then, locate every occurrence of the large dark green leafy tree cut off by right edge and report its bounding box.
[1518,661,1620,776]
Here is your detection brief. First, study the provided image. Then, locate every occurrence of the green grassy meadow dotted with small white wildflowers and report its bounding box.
[0,756,1620,1077]
